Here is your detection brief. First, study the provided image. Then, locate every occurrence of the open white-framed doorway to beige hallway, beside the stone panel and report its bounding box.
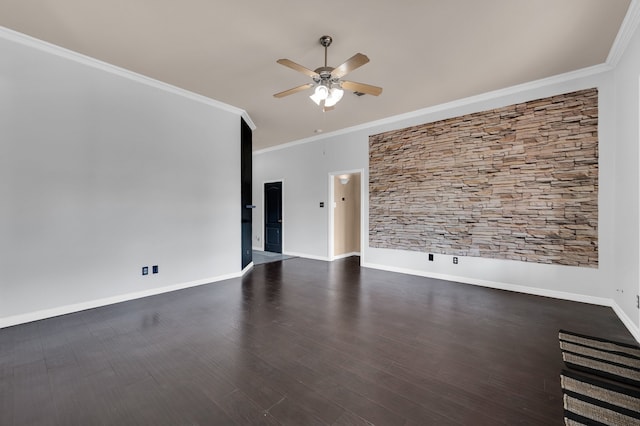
[329,170,363,260]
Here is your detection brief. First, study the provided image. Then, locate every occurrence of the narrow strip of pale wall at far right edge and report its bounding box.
[612,15,640,328]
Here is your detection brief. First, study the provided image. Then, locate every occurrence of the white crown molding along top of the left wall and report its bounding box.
[0,26,256,130]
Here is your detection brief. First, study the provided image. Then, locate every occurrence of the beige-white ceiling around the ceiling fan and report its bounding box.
[0,0,630,149]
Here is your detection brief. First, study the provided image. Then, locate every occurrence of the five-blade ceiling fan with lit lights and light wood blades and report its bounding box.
[273,35,382,111]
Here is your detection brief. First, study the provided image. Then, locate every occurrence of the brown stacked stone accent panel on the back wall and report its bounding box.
[369,88,598,267]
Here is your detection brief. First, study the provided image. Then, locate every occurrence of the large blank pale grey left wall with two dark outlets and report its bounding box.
[0,30,246,327]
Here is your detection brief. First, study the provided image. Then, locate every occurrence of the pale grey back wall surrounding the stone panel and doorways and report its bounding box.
[254,66,638,322]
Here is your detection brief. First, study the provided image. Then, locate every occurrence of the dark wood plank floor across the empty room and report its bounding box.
[0,258,633,425]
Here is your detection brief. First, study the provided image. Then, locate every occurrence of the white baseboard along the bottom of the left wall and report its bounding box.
[0,270,244,329]
